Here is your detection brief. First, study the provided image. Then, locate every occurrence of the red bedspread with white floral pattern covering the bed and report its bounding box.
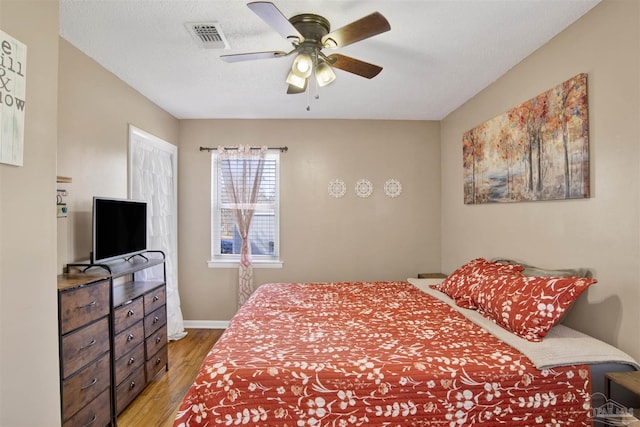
[174,282,592,427]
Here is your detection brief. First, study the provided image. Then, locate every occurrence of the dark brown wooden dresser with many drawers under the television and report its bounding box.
[58,251,168,427]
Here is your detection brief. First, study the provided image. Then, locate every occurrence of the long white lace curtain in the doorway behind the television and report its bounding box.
[129,127,187,340]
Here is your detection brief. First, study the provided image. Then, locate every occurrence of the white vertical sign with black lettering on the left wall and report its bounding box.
[0,30,27,166]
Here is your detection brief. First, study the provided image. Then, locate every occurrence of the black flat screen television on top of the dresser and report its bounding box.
[91,197,147,264]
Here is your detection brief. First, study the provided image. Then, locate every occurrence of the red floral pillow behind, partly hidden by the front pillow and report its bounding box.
[433,258,524,300]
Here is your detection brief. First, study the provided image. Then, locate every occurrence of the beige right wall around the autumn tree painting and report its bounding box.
[441,0,640,359]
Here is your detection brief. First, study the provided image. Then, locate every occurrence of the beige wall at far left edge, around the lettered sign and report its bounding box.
[0,0,60,427]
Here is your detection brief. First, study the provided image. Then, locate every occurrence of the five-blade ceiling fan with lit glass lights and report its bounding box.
[220,1,391,96]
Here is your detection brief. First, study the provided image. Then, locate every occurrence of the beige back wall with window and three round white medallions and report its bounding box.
[178,120,440,320]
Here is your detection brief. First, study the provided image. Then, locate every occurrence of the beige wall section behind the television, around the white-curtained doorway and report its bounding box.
[58,38,179,269]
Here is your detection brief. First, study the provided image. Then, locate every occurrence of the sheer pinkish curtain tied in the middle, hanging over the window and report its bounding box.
[218,145,268,307]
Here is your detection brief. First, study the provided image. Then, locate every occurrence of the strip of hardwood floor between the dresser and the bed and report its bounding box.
[118,329,224,427]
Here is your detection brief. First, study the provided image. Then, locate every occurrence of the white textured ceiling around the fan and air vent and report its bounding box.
[60,0,600,120]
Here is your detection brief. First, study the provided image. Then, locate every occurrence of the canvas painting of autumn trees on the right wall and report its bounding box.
[462,74,589,204]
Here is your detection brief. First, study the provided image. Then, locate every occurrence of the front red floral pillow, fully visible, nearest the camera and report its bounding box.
[471,274,597,341]
